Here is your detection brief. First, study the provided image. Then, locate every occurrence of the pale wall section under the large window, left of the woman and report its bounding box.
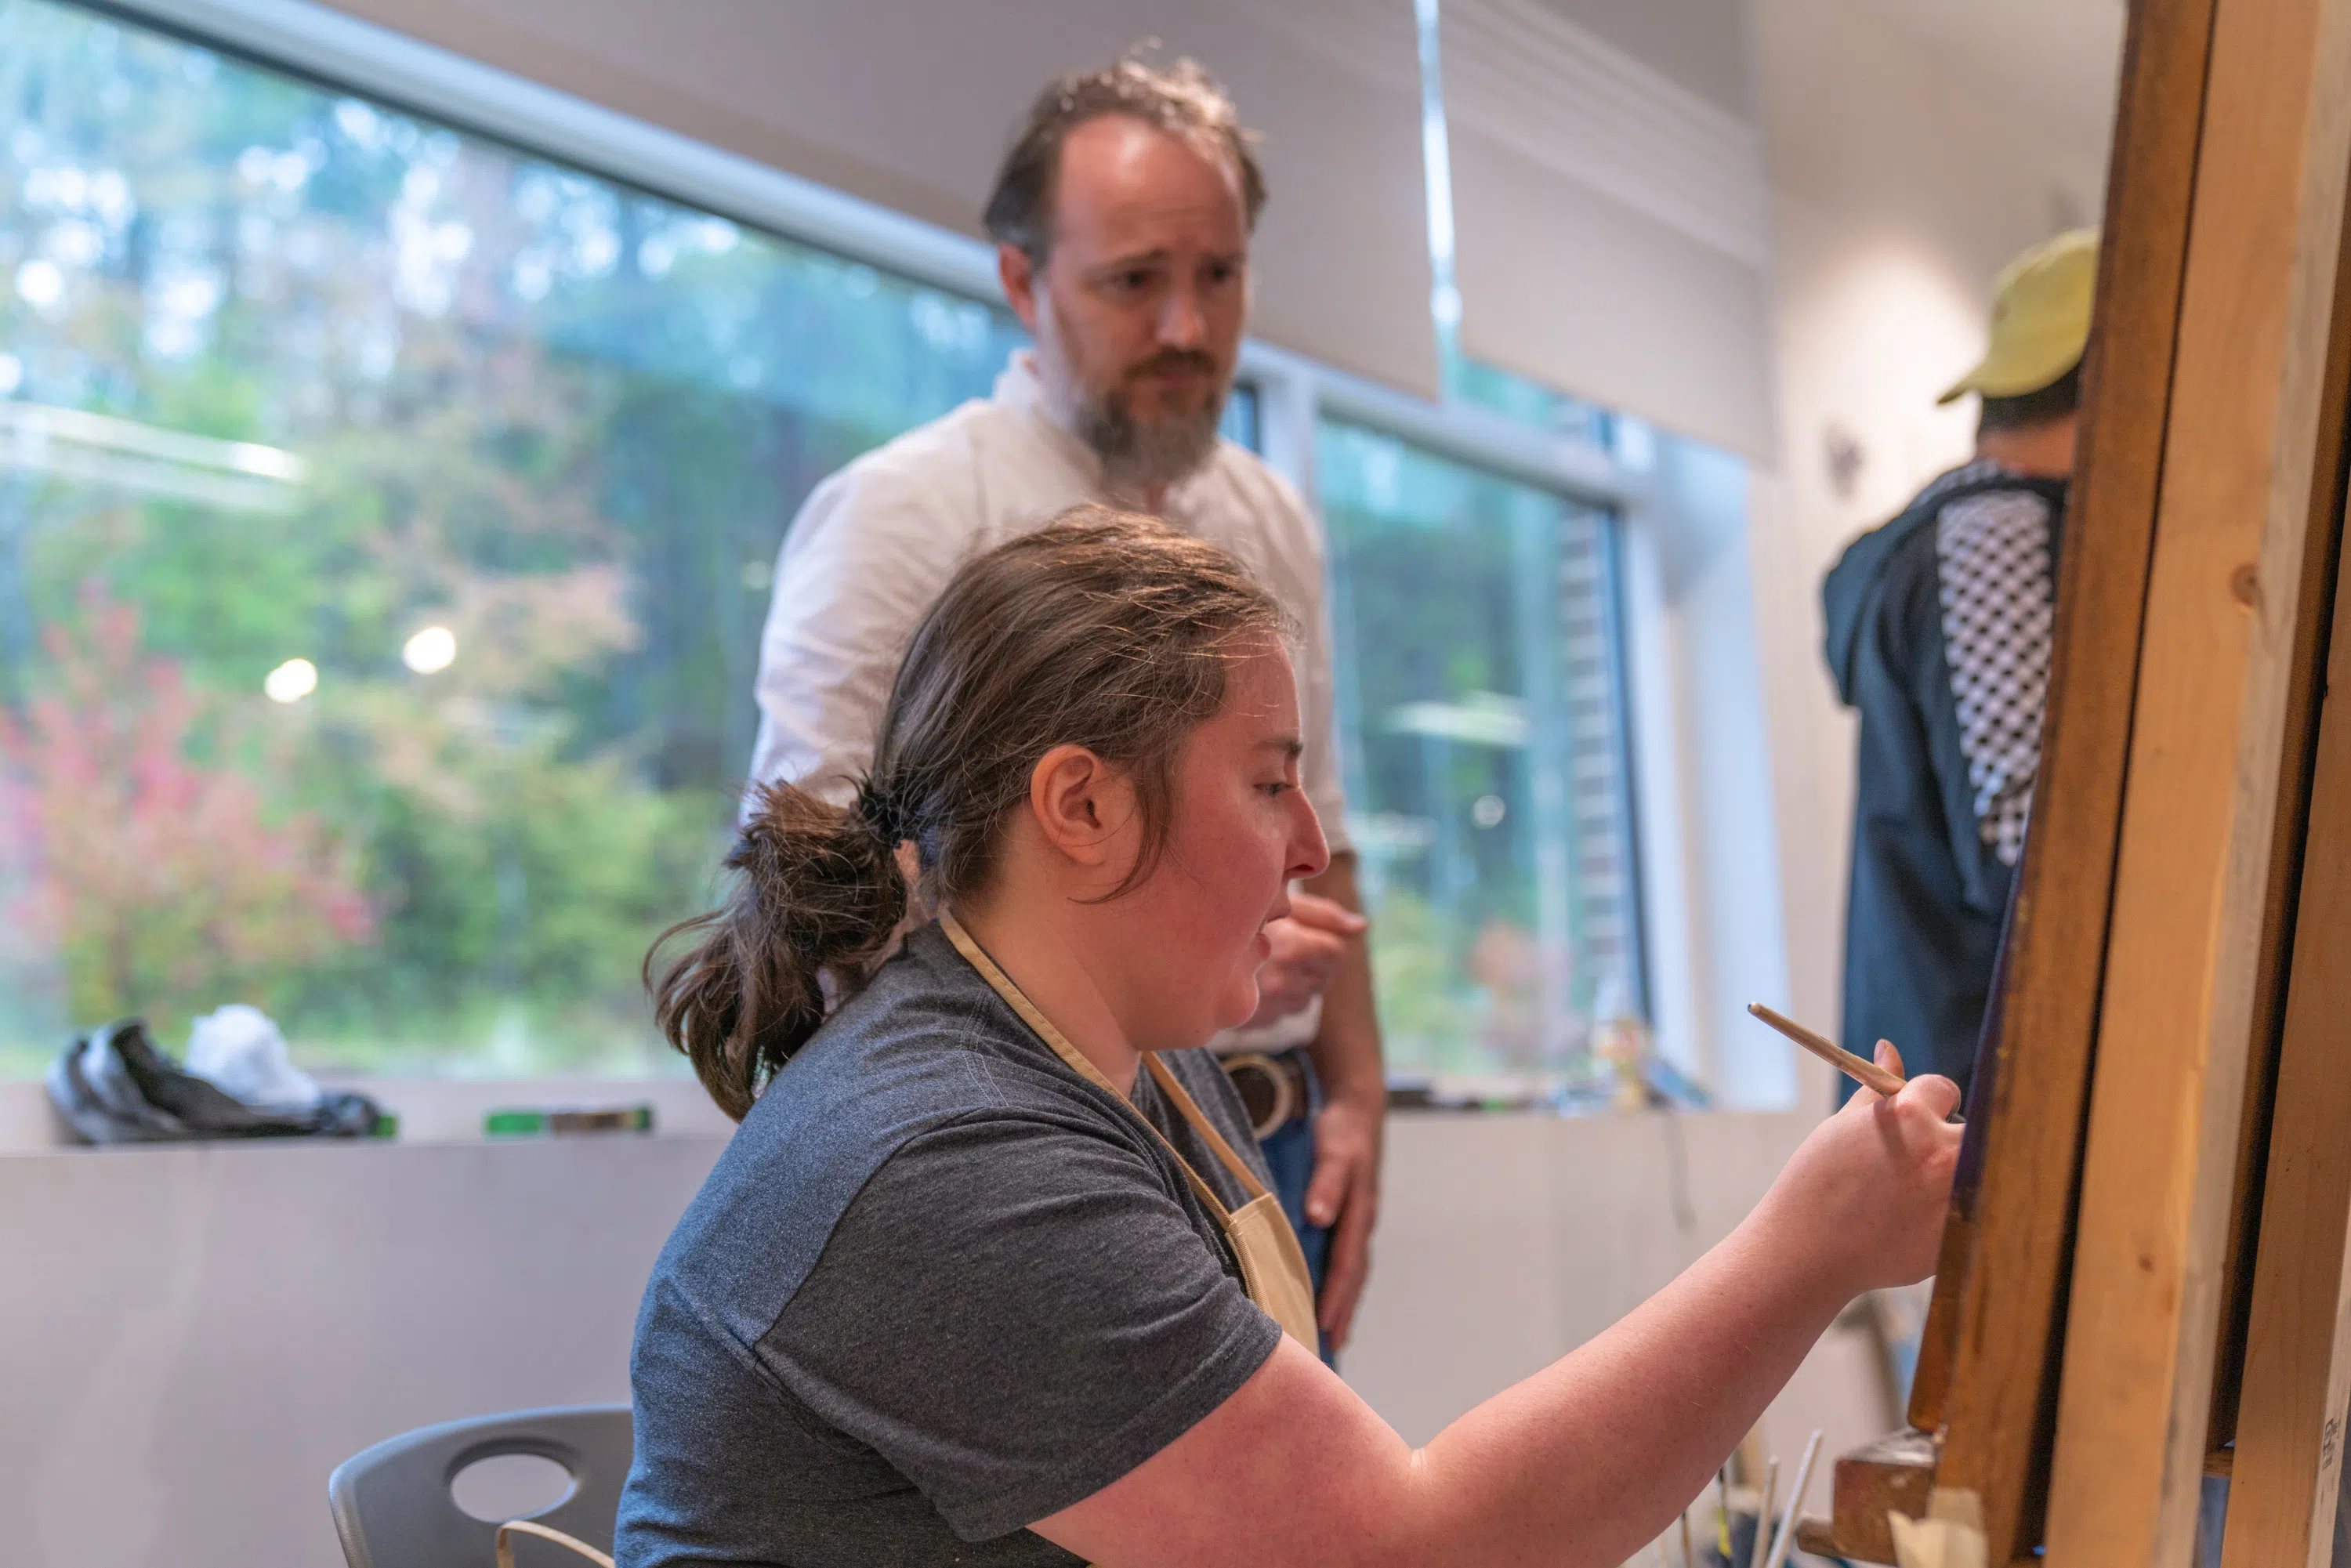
[0,1138,719,1568]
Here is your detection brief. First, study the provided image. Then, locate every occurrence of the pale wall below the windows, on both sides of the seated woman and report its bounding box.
[0,1114,1869,1568]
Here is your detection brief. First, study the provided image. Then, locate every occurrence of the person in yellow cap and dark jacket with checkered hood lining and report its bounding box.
[1822,230,2097,1105]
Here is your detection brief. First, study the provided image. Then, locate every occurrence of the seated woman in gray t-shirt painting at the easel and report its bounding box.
[618,508,1958,1568]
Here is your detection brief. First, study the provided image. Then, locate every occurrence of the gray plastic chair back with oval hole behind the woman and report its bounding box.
[327,1406,635,1568]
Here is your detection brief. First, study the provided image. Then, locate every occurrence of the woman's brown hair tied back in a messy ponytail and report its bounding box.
[644,505,1288,1121]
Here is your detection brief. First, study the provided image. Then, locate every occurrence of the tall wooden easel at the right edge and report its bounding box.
[1801,0,2351,1568]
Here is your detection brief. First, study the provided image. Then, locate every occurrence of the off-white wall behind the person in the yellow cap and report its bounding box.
[1749,0,2123,1044]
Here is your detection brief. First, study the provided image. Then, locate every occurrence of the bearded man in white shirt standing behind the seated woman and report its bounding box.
[752,61,1387,1349]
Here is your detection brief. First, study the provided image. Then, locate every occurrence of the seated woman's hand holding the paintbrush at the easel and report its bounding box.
[1759,1039,1961,1295]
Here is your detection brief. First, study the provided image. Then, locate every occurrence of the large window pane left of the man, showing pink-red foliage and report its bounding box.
[0,0,1049,1074]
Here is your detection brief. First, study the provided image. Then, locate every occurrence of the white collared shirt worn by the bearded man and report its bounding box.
[750,350,1347,853]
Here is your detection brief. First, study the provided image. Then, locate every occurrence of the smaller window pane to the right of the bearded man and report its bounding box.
[1317,423,1641,1098]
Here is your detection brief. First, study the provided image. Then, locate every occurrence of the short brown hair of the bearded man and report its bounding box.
[980,56,1265,266]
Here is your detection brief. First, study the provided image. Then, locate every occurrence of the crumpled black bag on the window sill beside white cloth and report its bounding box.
[42,1018,381,1143]
